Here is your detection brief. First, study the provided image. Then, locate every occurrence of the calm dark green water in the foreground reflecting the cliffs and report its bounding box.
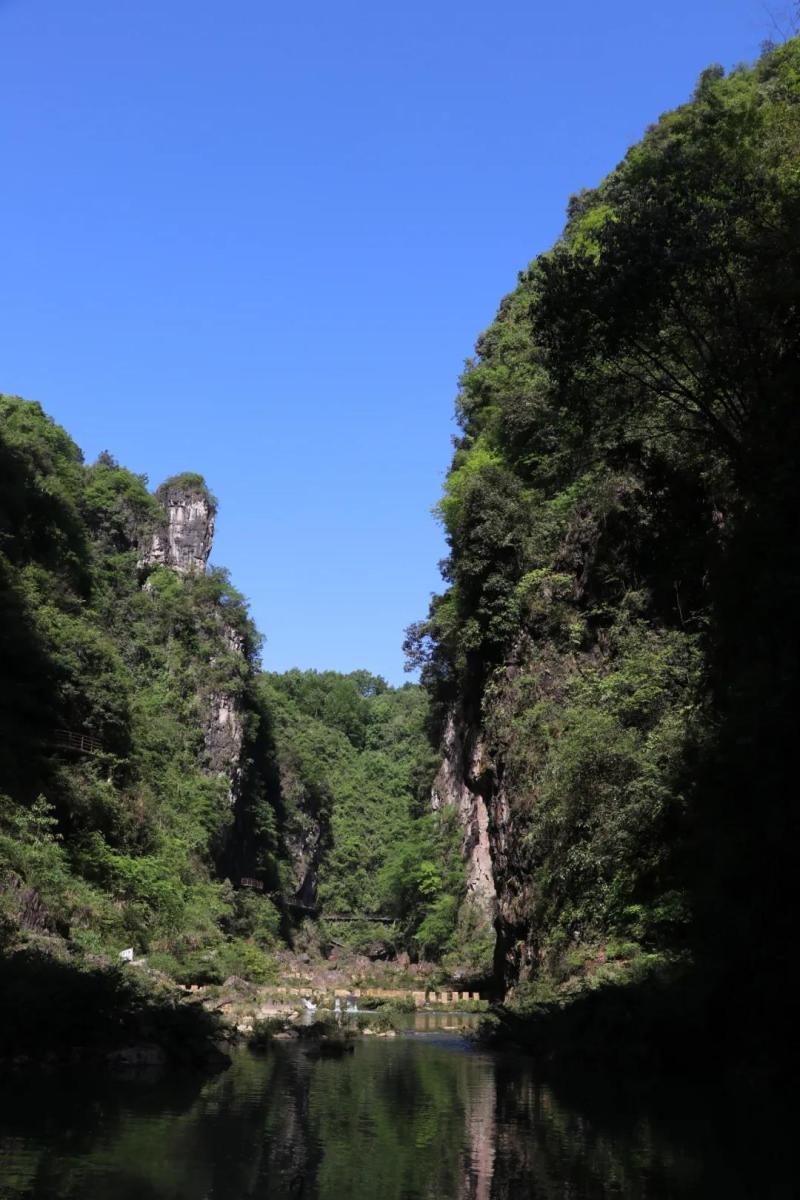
[0,1018,786,1200]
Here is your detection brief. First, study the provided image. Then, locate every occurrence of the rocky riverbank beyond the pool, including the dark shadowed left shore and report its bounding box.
[0,946,488,1070]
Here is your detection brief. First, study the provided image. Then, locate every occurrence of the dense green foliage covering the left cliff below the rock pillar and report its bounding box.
[0,397,279,974]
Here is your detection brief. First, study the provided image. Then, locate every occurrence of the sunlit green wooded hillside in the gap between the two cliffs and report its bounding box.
[257,671,464,958]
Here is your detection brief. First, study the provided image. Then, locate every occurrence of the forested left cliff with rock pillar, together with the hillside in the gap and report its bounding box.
[0,396,465,983]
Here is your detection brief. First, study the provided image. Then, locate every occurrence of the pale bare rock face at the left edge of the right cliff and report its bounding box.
[431,713,497,919]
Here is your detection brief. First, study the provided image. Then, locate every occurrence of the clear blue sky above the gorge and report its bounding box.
[0,0,775,682]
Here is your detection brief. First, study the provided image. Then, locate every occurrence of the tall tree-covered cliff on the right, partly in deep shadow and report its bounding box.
[408,41,800,1056]
